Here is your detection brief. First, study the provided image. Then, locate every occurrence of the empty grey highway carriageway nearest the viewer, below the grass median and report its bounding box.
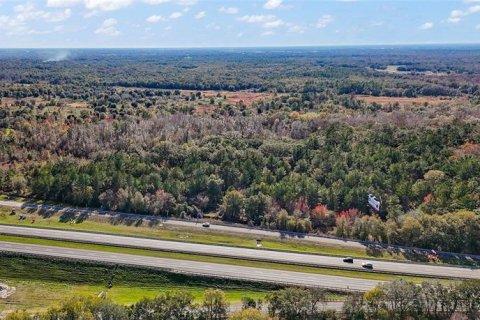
[0,241,380,291]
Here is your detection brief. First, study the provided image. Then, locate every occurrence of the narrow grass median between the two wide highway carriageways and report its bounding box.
[0,235,432,283]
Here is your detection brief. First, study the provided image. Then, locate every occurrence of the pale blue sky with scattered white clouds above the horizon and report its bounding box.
[0,0,480,48]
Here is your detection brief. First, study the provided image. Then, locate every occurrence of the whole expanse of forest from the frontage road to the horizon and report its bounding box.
[0,47,480,253]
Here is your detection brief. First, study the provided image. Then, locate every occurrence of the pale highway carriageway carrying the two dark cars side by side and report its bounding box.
[0,225,480,279]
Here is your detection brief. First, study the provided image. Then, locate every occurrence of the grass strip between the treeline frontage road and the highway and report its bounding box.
[0,207,406,260]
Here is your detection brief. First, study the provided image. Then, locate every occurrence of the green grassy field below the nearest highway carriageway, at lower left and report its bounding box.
[0,254,280,312]
